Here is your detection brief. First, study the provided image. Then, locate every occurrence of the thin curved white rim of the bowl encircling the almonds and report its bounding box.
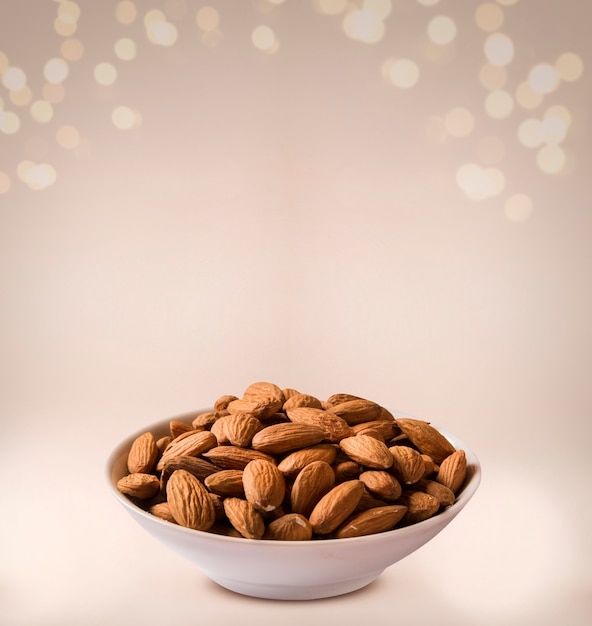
[105,407,482,550]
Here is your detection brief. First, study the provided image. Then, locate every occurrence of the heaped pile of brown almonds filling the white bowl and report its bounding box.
[117,382,466,541]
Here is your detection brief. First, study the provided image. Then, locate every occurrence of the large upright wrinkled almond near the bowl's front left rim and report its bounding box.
[166,470,216,530]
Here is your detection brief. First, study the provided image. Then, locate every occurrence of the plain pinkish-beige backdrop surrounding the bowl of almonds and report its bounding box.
[0,0,592,626]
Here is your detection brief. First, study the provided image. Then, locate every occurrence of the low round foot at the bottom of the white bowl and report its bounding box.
[209,571,382,600]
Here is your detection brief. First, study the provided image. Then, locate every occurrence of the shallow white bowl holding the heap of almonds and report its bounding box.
[107,409,481,600]
